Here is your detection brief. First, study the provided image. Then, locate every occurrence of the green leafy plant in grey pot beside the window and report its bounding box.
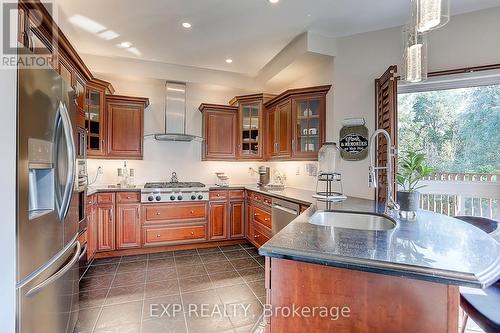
[396,150,432,212]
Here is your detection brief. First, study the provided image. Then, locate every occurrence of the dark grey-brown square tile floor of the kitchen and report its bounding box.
[75,244,265,333]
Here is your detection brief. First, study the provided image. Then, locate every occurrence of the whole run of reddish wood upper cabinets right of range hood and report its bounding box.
[200,85,331,161]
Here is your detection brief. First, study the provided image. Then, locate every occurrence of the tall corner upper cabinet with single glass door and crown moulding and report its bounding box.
[229,94,275,160]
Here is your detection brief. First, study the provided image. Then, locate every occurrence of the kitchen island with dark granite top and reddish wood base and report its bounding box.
[259,198,500,333]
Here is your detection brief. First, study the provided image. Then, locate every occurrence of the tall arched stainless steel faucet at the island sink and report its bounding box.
[368,129,399,214]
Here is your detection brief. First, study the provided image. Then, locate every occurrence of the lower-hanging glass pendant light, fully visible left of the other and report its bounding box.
[402,26,427,83]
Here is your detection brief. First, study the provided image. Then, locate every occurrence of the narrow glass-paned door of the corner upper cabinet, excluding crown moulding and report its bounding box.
[239,102,262,159]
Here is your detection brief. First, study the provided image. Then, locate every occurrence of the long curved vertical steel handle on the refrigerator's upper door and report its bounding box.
[58,102,76,220]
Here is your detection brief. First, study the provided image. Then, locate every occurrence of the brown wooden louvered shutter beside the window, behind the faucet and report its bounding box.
[375,65,398,202]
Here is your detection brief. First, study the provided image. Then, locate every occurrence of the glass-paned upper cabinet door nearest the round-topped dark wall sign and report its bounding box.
[293,97,324,157]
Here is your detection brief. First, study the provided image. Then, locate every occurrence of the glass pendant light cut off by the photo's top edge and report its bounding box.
[411,0,450,33]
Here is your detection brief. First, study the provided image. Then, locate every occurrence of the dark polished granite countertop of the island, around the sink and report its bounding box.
[259,198,500,288]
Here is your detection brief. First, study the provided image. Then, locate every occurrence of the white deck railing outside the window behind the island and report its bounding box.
[419,173,500,220]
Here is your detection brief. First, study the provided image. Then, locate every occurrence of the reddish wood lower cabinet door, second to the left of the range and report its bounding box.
[97,204,115,251]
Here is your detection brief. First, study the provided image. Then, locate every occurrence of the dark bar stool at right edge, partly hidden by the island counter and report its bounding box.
[455,216,500,333]
